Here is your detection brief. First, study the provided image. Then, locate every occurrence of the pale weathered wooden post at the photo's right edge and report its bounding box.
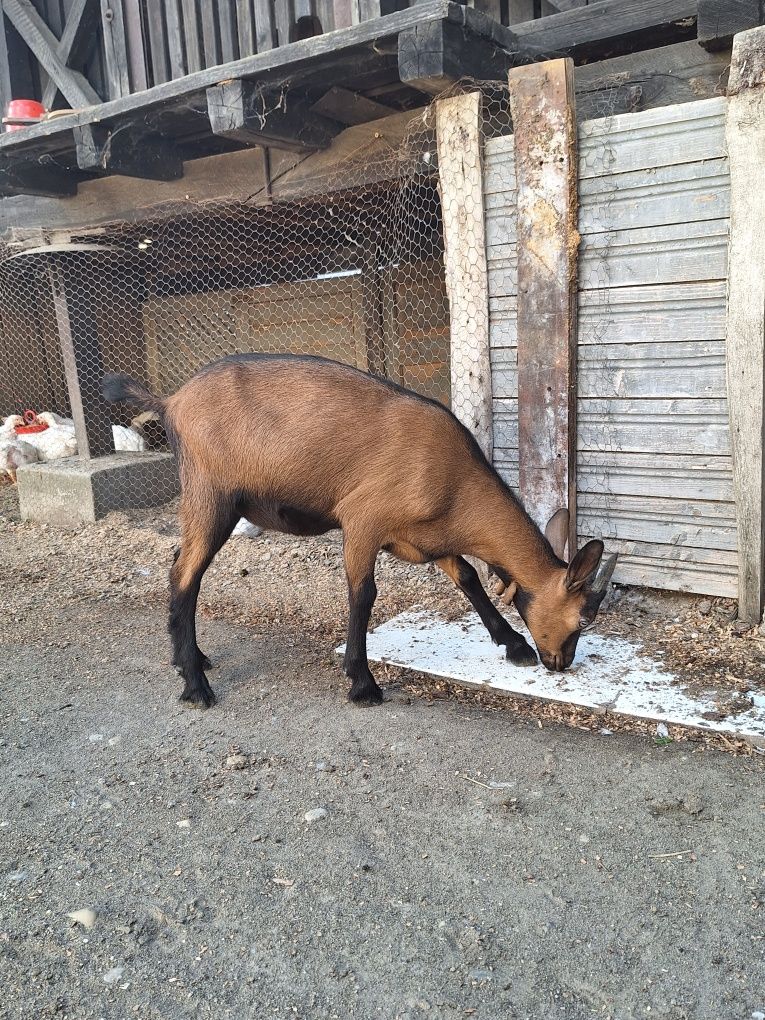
[725,29,765,623]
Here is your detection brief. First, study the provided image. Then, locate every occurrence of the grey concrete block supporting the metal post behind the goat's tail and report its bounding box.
[17,453,180,527]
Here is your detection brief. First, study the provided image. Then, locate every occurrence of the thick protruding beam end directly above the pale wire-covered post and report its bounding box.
[399,21,515,96]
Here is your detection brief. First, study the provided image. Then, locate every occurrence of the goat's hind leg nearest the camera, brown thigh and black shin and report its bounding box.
[169,494,236,708]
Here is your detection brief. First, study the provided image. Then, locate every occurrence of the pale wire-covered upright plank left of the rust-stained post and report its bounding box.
[436,92,494,461]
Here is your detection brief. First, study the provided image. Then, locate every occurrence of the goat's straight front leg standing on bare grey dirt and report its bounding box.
[343,534,383,705]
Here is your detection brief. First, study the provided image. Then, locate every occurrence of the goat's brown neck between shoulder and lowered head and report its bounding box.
[461,470,563,594]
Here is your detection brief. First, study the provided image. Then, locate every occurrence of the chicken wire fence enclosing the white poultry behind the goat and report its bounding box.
[0,86,516,506]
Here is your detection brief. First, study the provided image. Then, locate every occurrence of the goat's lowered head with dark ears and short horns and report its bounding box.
[502,510,616,671]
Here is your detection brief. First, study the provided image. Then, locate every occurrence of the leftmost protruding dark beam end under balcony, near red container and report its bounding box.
[74,124,184,181]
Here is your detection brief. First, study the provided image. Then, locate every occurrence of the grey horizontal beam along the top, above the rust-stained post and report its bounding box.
[513,0,699,60]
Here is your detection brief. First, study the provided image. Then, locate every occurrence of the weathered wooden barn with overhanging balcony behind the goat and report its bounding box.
[0,0,765,621]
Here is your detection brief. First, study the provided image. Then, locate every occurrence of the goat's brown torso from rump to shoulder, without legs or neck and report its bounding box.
[165,355,482,512]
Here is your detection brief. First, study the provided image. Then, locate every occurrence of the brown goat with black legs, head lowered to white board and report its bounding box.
[102,354,615,706]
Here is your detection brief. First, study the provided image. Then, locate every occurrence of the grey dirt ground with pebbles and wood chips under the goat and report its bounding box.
[0,488,765,1020]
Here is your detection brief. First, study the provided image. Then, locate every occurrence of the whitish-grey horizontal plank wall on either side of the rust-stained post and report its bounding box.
[485,98,737,597]
